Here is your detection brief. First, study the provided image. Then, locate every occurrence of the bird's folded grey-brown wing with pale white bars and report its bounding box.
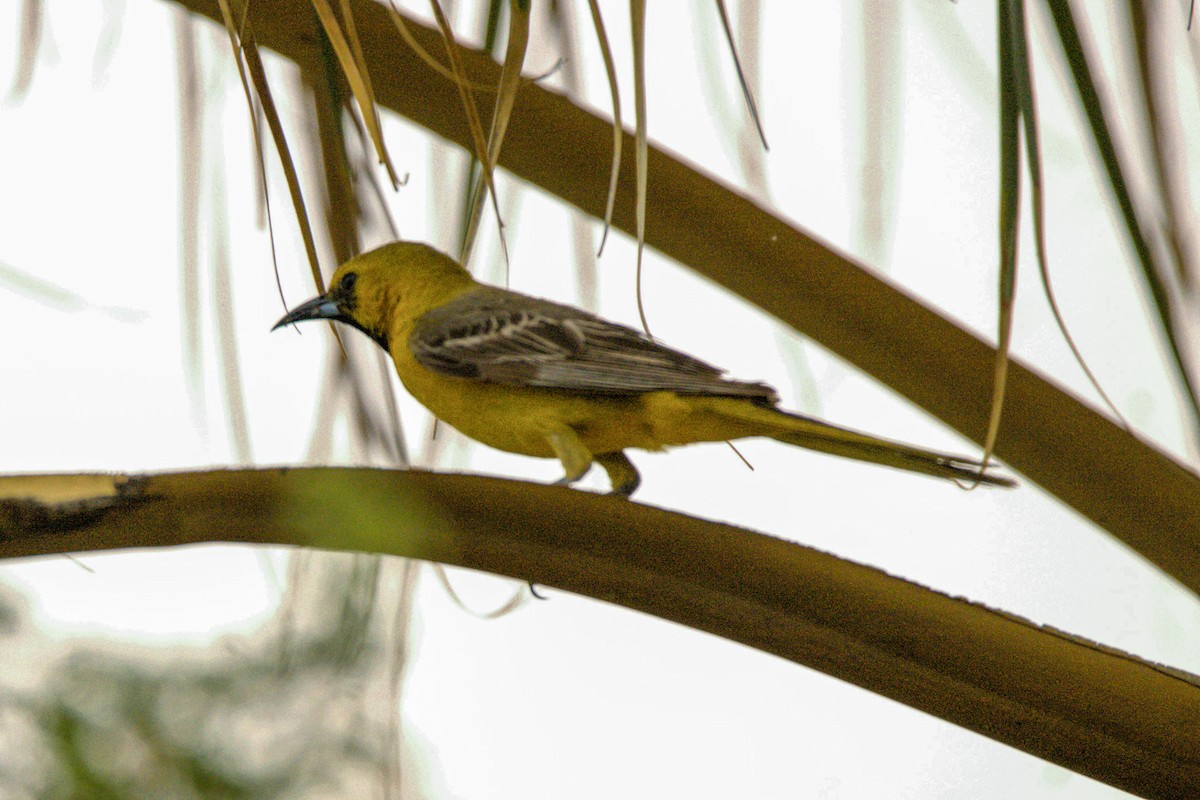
[408,287,776,403]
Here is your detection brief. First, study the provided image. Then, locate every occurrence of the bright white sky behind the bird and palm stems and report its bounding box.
[0,0,1200,800]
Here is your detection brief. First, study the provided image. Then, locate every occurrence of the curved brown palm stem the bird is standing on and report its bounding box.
[0,468,1200,798]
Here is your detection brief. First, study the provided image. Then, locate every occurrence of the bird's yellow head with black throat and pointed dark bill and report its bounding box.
[271,241,473,350]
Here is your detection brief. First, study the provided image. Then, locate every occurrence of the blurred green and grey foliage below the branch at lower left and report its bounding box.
[0,554,420,800]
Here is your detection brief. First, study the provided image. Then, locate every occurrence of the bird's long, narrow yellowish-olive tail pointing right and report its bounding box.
[713,399,1016,486]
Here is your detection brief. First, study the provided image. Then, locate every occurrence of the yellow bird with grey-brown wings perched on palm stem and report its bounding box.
[272,242,1013,497]
